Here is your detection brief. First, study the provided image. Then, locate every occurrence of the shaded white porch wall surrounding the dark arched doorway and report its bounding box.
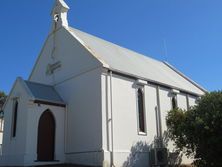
[24,103,66,166]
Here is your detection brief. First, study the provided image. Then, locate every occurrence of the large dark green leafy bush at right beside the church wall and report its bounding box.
[166,91,222,167]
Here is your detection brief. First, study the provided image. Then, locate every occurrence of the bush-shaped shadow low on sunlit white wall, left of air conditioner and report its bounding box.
[123,141,149,167]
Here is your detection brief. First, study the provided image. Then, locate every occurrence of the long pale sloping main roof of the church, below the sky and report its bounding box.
[69,27,205,95]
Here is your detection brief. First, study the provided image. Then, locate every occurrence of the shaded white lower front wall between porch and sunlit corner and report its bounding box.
[55,68,103,166]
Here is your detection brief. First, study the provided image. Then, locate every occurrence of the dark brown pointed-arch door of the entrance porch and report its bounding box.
[37,110,55,161]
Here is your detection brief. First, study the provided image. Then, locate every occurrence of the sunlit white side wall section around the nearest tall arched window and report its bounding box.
[102,74,153,166]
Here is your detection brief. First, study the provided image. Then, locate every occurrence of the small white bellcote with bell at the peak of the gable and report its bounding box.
[51,0,69,31]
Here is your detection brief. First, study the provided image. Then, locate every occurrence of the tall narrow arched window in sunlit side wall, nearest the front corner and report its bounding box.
[137,88,145,133]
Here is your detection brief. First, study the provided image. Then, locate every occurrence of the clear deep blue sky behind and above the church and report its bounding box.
[0,0,222,93]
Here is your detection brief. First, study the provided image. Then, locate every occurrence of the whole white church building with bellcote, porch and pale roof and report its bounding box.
[0,0,206,167]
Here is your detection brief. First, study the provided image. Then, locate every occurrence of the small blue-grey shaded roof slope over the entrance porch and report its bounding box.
[24,81,64,104]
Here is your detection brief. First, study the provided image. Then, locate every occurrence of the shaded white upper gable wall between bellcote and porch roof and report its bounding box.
[29,27,102,85]
